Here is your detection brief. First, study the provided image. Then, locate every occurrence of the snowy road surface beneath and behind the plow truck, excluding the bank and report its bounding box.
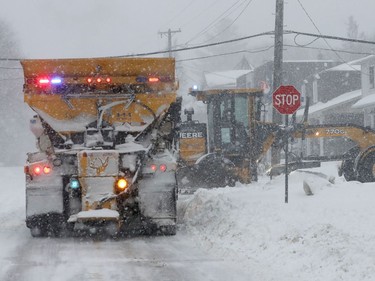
[0,168,251,281]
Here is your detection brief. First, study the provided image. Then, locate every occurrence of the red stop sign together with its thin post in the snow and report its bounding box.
[272,85,301,203]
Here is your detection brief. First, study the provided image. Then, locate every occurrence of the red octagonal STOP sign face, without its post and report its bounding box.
[272,85,301,114]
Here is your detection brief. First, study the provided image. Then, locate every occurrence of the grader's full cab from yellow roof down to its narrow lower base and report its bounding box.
[190,88,263,183]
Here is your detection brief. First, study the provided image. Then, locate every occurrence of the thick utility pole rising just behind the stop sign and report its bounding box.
[271,0,284,165]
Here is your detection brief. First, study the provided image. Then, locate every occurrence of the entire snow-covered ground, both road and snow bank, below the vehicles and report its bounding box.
[0,163,375,281]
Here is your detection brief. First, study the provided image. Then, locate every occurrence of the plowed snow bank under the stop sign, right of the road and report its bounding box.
[180,163,375,281]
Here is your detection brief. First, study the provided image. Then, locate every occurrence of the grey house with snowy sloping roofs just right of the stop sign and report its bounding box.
[297,60,364,156]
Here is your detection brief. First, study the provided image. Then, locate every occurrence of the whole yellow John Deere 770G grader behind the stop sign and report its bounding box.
[177,89,375,190]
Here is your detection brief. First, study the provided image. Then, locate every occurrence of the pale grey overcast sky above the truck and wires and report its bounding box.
[0,0,375,58]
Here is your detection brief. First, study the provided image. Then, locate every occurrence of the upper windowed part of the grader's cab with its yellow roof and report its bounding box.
[190,89,262,156]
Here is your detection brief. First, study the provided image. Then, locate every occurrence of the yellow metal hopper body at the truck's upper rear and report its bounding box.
[21,58,178,134]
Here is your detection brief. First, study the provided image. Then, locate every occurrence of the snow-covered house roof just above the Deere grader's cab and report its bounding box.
[204,70,252,89]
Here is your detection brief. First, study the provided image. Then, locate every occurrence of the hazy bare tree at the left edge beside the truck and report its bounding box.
[0,21,34,165]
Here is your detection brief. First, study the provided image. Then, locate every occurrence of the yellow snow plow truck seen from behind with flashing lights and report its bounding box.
[21,58,181,236]
